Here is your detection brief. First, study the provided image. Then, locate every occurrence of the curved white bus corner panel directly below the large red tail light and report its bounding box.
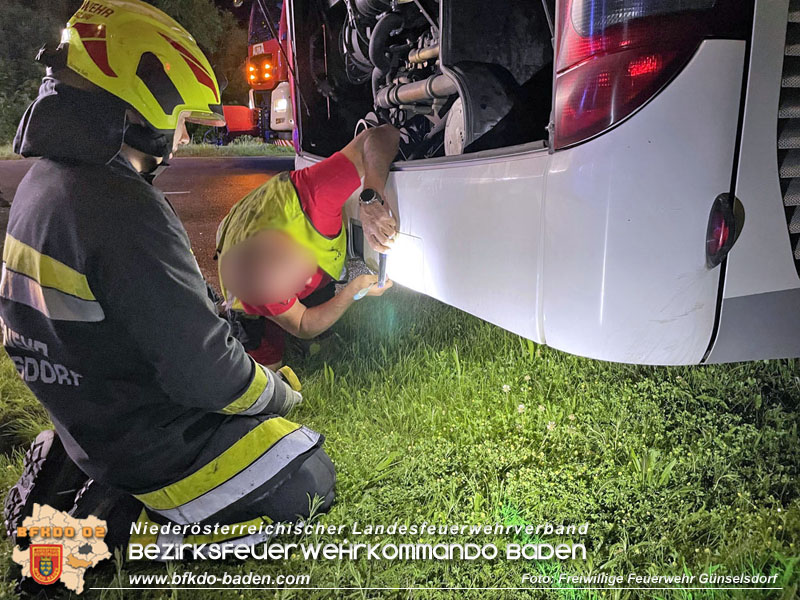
[542,40,745,364]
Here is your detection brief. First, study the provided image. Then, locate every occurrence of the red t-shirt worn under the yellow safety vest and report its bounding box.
[242,152,361,317]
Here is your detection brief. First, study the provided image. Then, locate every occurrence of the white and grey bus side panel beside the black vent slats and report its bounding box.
[706,0,800,363]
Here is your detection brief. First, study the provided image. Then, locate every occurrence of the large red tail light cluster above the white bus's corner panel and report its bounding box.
[553,0,752,149]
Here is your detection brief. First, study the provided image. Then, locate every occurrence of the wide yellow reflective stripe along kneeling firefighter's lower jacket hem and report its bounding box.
[135,417,300,510]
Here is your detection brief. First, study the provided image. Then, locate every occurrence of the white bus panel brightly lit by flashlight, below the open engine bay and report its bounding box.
[297,150,549,343]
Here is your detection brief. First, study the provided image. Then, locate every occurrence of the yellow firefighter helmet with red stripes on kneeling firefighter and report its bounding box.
[61,0,225,130]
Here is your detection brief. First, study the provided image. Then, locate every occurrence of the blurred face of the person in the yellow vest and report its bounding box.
[220,230,317,306]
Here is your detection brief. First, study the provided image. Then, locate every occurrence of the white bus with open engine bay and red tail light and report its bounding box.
[290,0,800,364]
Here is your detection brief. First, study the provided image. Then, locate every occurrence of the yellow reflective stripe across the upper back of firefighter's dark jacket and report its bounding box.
[3,234,96,300]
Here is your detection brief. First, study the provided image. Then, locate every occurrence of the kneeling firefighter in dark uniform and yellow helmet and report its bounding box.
[0,0,335,542]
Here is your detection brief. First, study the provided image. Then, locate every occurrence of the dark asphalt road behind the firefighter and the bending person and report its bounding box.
[0,156,294,285]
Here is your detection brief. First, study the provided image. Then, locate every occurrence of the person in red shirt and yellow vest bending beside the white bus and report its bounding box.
[217,125,400,370]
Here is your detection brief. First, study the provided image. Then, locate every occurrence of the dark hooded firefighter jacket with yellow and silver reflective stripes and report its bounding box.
[0,78,322,523]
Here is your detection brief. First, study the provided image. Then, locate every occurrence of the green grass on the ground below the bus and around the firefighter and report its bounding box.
[0,289,800,600]
